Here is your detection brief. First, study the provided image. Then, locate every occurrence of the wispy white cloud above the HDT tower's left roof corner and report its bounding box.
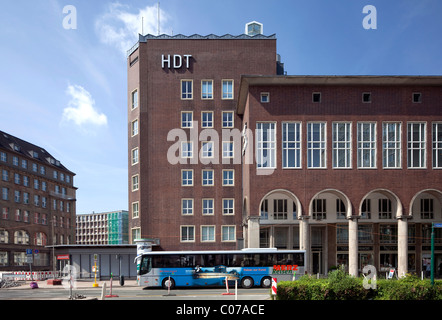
[95,3,169,55]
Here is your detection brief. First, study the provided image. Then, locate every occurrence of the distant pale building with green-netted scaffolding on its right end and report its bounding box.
[76,210,129,245]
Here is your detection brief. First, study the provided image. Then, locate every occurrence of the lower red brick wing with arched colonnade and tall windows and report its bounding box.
[237,76,442,276]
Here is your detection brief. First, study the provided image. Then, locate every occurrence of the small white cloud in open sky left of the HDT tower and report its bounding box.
[63,85,107,127]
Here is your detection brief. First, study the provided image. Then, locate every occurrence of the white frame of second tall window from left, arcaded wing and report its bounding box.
[282,122,302,169]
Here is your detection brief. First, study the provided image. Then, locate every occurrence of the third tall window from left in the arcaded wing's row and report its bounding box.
[307,122,327,168]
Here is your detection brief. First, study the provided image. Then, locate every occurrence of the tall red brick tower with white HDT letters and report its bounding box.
[128,23,281,250]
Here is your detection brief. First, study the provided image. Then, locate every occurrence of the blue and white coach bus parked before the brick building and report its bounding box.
[137,249,305,289]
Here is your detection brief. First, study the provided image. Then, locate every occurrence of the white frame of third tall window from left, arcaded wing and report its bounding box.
[307,122,327,169]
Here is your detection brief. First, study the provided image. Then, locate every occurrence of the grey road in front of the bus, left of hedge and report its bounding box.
[0,281,270,301]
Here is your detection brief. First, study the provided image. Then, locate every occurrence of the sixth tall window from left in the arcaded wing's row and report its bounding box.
[382,122,401,169]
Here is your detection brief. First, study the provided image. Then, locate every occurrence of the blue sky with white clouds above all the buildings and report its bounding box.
[0,0,442,214]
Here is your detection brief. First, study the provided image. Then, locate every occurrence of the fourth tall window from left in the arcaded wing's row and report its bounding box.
[333,122,351,168]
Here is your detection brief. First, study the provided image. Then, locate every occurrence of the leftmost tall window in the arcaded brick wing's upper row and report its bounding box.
[256,122,276,168]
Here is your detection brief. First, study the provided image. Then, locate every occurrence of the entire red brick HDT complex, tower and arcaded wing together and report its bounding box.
[128,23,442,275]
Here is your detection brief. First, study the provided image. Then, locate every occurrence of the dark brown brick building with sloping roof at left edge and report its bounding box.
[0,131,77,271]
